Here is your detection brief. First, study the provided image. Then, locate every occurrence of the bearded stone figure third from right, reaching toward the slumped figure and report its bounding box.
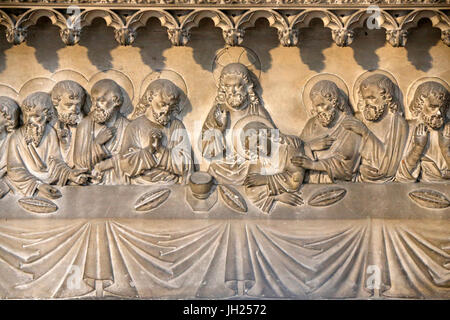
[292,80,361,183]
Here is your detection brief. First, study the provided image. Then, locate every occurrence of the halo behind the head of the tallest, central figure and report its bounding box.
[211,47,261,87]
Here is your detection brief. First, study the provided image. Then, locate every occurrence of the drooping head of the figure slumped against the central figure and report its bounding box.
[240,121,272,160]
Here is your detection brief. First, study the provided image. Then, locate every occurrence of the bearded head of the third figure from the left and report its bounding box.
[51,80,86,126]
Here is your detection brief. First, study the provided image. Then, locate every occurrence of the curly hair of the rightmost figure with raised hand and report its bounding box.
[409,81,450,117]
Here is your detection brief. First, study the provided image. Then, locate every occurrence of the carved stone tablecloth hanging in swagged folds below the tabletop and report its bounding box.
[0,219,450,298]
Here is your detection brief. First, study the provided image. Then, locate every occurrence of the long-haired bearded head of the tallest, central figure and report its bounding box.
[216,63,259,110]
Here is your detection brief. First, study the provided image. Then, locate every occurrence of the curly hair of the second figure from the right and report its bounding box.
[358,74,401,113]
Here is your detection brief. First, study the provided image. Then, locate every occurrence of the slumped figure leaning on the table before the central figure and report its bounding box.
[238,116,305,213]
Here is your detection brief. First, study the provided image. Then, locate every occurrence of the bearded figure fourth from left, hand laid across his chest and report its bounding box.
[73,79,129,184]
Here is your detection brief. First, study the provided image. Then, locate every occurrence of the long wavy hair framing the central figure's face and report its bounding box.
[215,63,261,112]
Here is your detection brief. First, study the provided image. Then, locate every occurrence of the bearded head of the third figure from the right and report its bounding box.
[309,80,349,127]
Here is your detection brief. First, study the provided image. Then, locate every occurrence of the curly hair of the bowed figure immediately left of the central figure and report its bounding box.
[135,79,181,116]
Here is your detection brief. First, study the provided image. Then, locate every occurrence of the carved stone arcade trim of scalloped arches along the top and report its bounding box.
[0,6,450,47]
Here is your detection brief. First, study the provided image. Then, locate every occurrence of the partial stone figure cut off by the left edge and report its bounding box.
[0,97,20,199]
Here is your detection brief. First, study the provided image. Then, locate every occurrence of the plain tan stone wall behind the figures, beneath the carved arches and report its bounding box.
[0,18,450,169]
